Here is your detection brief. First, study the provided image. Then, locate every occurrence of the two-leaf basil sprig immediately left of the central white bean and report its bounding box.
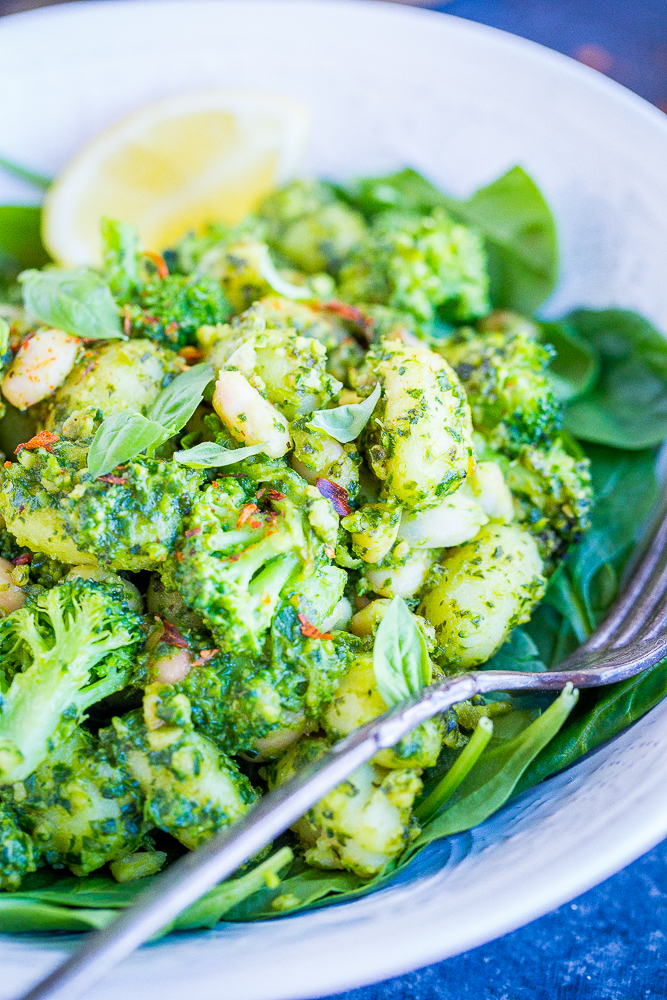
[88,364,215,479]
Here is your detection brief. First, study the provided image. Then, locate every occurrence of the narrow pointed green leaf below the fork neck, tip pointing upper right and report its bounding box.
[414,684,578,848]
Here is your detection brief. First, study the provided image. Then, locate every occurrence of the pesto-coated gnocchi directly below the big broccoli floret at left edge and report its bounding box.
[11,729,148,875]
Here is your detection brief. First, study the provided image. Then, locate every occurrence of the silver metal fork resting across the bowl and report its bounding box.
[15,497,667,1000]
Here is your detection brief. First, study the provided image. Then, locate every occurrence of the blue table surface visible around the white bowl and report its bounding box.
[0,0,667,1000]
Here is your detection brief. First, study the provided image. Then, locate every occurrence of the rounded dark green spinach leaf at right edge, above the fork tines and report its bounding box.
[565,309,667,450]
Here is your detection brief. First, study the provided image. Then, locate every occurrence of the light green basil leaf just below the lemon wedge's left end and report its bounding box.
[19,267,124,340]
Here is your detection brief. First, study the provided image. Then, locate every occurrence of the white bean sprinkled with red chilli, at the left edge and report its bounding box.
[2,329,80,410]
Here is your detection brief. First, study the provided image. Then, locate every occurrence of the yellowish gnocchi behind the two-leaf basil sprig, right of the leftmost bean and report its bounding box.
[44,339,181,431]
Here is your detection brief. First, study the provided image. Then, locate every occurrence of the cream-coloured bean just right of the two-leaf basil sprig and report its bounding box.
[213,371,292,458]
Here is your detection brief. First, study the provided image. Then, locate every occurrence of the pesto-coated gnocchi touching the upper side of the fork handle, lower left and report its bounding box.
[100,704,257,850]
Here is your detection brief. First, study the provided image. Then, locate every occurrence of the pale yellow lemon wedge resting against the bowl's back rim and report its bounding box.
[42,90,309,266]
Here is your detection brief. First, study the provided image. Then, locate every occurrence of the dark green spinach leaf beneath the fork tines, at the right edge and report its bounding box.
[515,660,667,795]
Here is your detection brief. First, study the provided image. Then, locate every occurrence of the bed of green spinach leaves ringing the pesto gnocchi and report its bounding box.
[0,160,667,933]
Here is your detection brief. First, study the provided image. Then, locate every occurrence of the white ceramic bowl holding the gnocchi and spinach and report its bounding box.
[0,0,667,1000]
